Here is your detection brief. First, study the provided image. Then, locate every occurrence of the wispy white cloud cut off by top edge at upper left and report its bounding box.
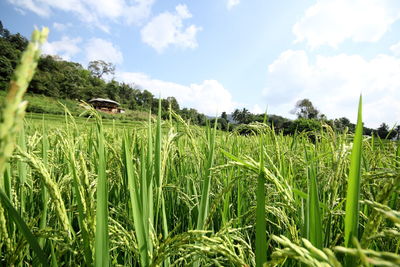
[8,0,155,31]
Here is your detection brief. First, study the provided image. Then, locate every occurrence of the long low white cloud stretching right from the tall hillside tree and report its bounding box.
[116,72,235,116]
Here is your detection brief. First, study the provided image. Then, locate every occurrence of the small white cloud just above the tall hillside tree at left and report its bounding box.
[85,38,123,64]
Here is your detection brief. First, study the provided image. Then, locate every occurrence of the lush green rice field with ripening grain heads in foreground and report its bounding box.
[0,28,400,266]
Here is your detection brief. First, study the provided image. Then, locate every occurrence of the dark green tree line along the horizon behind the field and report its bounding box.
[0,21,400,139]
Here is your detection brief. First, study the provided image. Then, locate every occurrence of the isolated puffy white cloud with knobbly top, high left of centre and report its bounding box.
[141,5,201,53]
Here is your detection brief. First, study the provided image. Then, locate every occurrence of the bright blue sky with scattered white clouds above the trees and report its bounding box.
[0,0,400,127]
